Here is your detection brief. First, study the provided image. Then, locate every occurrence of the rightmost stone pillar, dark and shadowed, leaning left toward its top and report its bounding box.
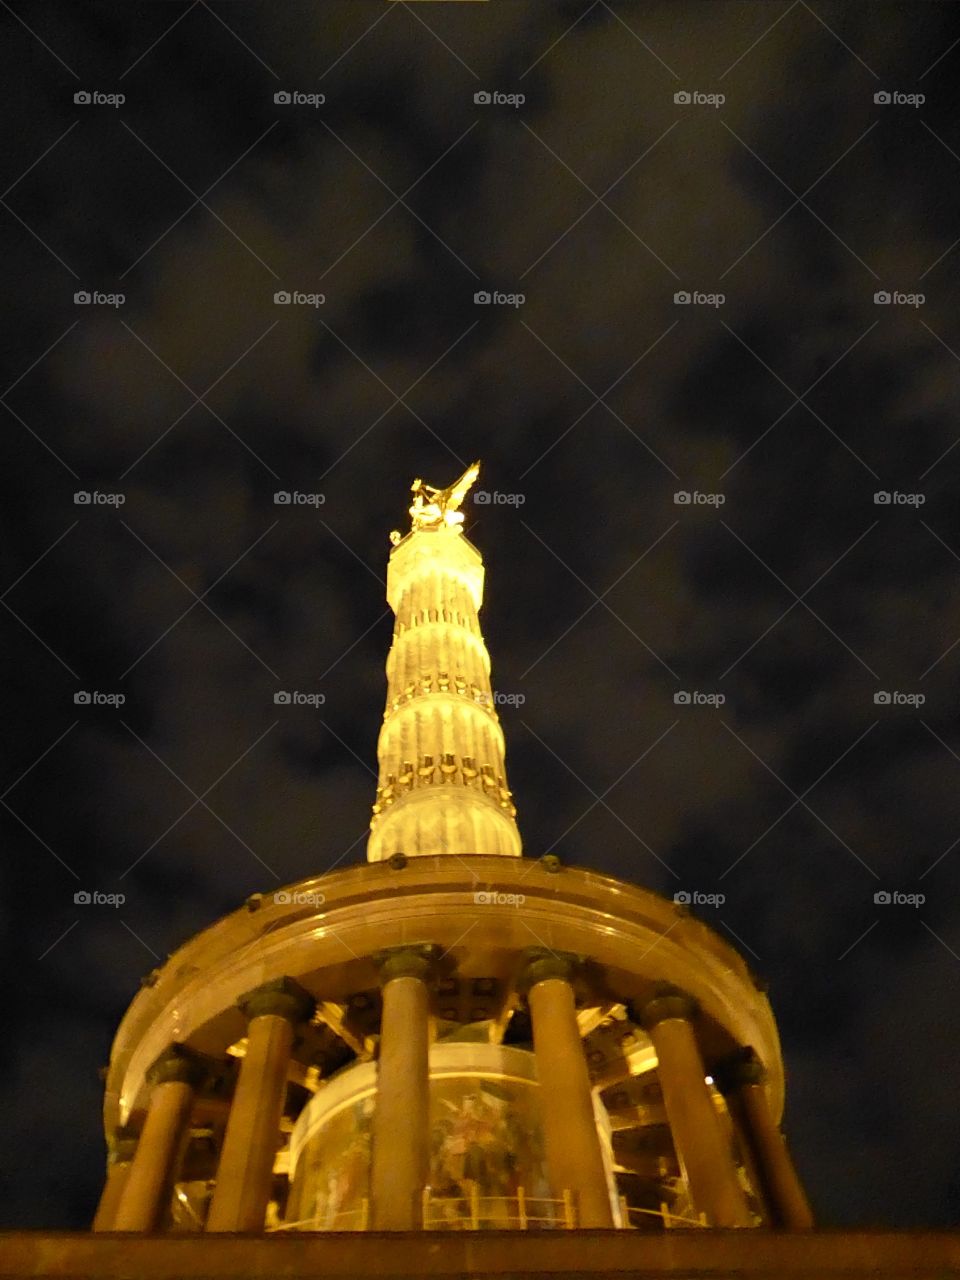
[713,1048,814,1231]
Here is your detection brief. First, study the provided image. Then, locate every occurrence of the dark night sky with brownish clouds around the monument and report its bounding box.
[0,0,960,1228]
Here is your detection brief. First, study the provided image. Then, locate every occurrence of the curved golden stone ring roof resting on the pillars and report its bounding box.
[104,855,783,1134]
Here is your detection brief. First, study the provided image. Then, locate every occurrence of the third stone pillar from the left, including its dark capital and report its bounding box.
[206,978,315,1231]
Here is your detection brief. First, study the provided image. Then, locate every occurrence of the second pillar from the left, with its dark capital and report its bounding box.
[110,1044,205,1231]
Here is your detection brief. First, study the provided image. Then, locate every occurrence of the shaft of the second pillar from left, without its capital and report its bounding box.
[111,1080,193,1231]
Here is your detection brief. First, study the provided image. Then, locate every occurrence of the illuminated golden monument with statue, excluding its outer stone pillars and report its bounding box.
[94,463,783,1231]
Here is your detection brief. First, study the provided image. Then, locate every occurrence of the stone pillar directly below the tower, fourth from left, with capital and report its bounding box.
[370,946,436,1231]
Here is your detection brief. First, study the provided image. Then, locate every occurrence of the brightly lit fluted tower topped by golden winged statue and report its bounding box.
[367,463,521,863]
